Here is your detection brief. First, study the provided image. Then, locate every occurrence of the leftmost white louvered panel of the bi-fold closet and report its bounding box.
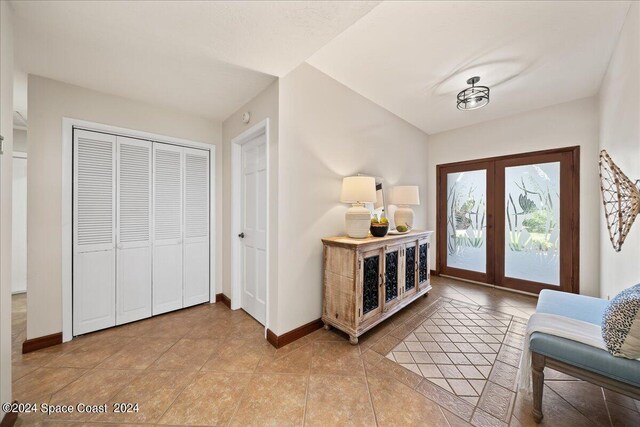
[73,130,116,335]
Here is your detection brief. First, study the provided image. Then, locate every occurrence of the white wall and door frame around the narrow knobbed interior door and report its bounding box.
[222,80,279,330]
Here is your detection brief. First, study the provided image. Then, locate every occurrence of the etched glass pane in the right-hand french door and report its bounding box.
[504,162,560,285]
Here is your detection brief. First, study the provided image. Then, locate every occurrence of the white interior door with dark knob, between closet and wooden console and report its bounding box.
[239,134,267,325]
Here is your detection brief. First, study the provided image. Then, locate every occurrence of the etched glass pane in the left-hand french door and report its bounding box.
[447,170,487,273]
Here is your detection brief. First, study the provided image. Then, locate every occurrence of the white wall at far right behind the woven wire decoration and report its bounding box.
[599,3,640,298]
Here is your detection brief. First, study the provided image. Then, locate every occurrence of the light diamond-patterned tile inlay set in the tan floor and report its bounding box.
[386,297,526,412]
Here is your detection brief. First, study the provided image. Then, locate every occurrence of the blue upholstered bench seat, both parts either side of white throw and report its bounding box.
[529,290,640,387]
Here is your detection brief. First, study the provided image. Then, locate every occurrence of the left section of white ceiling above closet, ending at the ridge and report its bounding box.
[12,1,378,120]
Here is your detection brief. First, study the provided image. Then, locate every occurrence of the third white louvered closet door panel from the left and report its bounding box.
[153,142,184,315]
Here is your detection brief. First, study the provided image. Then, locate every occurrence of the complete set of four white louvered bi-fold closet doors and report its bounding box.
[73,129,210,335]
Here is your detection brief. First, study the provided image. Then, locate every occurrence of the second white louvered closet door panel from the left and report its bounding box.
[116,136,152,325]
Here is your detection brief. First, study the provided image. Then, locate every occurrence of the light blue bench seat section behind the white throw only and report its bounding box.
[536,289,609,325]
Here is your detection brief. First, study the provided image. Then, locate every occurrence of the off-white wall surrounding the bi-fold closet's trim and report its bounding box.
[27,75,222,339]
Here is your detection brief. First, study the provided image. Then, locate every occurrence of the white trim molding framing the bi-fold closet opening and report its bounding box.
[62,117,220,342]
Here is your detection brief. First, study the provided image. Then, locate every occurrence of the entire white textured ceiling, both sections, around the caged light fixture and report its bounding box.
[12,1,630,133]
